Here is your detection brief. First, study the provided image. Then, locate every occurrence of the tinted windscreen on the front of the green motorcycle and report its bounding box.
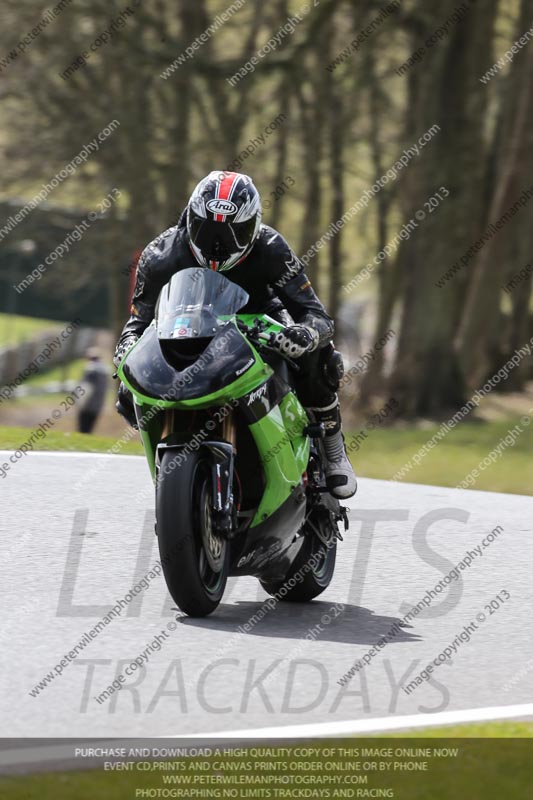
[156,267,249,339]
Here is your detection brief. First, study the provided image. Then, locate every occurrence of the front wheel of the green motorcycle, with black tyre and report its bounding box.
[156,450,229,617]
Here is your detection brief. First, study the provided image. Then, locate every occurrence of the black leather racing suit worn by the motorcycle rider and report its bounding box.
[117,214,342,408]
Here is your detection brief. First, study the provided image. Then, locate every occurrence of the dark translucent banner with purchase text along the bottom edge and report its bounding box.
[0,736,533,800]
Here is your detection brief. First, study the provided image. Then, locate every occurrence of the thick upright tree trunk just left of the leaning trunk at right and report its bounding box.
[390,0,497,417]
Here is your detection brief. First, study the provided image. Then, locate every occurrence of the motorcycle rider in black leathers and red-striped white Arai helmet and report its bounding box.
[114,171,357,499]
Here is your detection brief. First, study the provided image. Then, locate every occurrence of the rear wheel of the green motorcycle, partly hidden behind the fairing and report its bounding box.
[261,530,337,603]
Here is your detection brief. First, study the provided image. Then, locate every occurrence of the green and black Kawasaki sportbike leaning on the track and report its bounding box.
[119,268,348,616]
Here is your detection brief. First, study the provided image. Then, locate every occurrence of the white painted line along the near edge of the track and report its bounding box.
[184,703,533,739]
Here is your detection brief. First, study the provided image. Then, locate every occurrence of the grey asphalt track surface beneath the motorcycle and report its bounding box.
[0,453,533,760]
